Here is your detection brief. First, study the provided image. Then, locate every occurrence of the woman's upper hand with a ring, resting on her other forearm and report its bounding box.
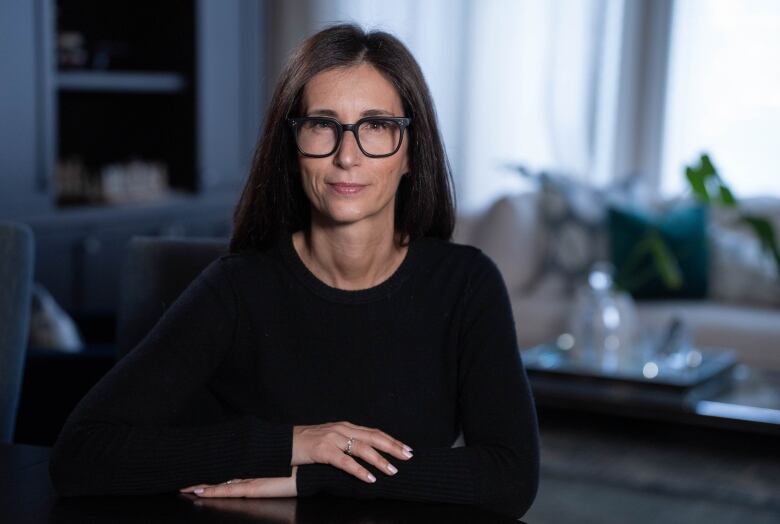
[291,422,412,483]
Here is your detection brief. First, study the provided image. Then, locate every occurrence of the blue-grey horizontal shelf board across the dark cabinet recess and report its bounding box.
[56,71,188,93]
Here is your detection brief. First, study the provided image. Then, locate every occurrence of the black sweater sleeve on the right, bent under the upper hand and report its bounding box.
[297,253,539,517]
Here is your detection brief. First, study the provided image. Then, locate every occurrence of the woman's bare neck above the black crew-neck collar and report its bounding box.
[293,215,407,290]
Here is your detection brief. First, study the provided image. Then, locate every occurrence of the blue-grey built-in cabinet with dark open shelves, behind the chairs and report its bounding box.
[0,0,268,444]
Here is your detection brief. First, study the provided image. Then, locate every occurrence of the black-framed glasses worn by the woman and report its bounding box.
[287,116,412,158]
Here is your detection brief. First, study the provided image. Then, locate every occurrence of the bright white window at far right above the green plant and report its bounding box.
[661,0,780,197]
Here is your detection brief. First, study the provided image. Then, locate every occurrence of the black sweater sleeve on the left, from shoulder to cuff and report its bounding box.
[50,261,292,495]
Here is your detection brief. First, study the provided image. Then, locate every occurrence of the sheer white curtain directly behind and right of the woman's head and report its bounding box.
[312,0,622,212]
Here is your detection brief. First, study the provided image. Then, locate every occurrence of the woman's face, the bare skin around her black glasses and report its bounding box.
[299,64,409,225]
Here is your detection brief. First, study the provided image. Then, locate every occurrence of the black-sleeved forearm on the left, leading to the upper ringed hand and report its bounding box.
[50,416,292,496]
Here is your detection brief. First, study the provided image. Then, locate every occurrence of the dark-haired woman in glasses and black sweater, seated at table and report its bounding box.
[51,25,538,515]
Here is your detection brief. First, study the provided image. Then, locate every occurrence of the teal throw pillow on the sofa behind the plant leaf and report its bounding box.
[608,205,709,299]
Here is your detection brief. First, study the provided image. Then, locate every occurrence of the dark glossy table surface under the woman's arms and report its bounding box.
[0,444,517,524]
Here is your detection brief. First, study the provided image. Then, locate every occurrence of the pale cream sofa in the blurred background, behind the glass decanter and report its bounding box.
[454,190,780,370]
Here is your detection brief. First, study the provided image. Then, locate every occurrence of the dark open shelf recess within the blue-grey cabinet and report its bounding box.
[54,0,198,207]
